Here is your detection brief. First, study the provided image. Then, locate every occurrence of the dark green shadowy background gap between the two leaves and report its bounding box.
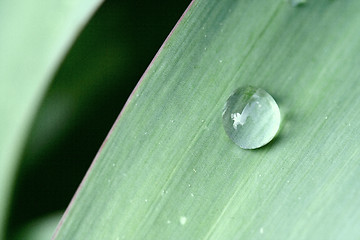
[7,0,190,239]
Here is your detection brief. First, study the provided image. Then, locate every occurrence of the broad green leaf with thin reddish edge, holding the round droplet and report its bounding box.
[54,0,360,239]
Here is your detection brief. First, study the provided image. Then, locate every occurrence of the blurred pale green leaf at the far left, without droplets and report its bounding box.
[0,0,101,238]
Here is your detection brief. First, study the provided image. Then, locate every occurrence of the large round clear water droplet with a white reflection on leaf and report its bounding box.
[222,86,280,149]
